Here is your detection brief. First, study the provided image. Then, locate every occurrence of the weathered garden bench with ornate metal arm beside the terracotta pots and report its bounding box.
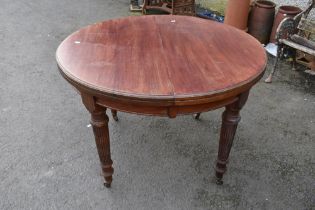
[265,0,315,83]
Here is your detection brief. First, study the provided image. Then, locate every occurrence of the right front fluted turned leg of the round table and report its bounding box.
[215,91,249,185]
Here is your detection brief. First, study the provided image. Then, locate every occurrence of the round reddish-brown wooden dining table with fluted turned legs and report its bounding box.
[56,15,267,187]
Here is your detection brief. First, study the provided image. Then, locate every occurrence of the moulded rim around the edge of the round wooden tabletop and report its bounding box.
[55,17,267,104]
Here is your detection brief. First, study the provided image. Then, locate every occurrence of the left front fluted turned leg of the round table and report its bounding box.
[82,95,114,187]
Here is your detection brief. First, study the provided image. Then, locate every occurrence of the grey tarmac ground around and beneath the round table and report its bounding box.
[0,0,315,210]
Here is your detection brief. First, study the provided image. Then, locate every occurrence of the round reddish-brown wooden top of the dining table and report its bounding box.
[56,15,267,100]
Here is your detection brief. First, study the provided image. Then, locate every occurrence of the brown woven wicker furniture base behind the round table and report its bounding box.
[142,0,196,16]
